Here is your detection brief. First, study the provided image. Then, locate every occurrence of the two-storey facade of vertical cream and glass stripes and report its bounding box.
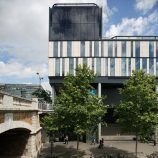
[49,40,158,77]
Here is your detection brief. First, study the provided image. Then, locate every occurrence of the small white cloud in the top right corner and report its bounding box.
[135,0,158,14]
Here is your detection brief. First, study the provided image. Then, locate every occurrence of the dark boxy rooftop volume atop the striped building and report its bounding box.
[49,4,102,41]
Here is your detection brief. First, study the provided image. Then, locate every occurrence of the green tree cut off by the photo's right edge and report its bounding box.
[116,70,158,156]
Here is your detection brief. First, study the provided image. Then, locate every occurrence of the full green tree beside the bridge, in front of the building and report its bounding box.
[42,65,106,150]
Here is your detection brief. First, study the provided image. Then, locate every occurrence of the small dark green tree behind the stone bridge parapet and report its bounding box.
[32,88,52,103]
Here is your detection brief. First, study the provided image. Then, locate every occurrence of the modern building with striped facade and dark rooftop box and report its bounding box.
[48,4,158,139]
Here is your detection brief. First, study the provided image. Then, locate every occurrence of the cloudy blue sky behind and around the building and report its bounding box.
[0,0,158,90]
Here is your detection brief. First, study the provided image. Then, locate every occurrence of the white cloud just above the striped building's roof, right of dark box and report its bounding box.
[106,11,158,37]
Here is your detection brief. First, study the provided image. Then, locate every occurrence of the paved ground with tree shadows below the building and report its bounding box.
[39,141,158,158]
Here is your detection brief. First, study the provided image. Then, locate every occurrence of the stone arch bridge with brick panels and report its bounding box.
[0,91,51,158]
